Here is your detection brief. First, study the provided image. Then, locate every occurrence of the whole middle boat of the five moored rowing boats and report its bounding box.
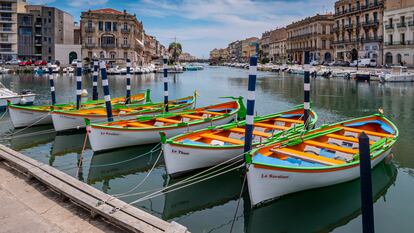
[87,98,245,151]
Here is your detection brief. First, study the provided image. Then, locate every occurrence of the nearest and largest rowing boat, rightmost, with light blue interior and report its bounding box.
[246,115,398,206]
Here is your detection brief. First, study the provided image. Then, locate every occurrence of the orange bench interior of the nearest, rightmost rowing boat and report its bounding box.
[252,117,394,166]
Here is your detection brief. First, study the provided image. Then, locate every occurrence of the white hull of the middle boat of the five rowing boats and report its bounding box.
[89,114,237,152]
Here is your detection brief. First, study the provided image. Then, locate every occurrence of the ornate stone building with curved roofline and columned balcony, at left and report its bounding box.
[80,8,146,65]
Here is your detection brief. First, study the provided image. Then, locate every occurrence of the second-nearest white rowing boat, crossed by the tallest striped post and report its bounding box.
[162,105,317,176]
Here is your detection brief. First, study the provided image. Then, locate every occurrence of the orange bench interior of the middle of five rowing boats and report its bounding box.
[98,101,238,128]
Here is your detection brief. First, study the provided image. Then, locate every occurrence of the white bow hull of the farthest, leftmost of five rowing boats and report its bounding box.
[9,107,52,128]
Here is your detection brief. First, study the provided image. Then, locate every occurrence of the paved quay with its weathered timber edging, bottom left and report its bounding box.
[0,145,189,233]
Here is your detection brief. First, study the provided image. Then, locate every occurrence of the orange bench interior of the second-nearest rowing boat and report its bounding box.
[174,109,303,145]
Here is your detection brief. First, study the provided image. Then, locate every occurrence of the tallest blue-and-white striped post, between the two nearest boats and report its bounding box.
[244,56,257,152]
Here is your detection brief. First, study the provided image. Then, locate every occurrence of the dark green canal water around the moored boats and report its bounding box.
[0,67,414,233]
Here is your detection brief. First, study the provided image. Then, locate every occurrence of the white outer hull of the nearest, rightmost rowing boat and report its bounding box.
[247,148,391,206]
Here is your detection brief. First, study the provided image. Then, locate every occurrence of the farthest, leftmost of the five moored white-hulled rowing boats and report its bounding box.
[8,90,150,128]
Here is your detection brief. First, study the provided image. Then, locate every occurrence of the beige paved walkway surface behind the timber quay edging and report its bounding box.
[0,162,121,233]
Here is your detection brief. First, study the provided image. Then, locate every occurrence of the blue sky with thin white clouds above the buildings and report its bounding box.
[28,0,335,58]
